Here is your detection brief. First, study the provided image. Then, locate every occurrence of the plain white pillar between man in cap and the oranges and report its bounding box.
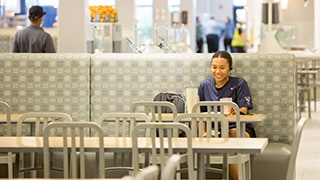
[58,0,89,53]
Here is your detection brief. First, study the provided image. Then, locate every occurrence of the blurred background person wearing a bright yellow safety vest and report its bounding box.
[231,22,247,53]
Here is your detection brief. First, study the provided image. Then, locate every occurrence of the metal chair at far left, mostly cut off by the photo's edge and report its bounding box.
[0,101,16,179]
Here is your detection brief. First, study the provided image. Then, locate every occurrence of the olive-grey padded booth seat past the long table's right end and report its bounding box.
[251,142,291,180]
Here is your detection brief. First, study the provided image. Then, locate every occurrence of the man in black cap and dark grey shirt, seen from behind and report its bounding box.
[12,6,56,53]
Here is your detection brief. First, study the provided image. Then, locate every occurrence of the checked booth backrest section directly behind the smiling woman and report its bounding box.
[91,53,297,143]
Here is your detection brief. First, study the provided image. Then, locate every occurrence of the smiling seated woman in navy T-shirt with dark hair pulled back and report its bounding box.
[198,51,256,179]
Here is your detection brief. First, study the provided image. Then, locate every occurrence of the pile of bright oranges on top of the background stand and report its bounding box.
[89,5,118,23]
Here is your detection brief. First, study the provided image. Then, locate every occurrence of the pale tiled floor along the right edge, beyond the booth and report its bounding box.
[296,101,320,180]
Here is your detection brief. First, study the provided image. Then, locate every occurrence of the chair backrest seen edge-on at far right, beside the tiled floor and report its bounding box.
[287,117,307,180]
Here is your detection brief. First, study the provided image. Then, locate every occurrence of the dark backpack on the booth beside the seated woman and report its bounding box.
[153,92,186,113]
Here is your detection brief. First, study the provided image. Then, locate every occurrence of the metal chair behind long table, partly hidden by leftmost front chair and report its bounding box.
[17,112,72,177]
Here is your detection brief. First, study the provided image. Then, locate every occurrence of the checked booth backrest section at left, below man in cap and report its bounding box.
[0,53,90,126]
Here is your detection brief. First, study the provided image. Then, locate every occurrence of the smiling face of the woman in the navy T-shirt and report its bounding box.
[211,57,230,83]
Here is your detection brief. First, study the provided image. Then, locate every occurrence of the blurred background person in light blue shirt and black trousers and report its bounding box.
[206,16,224,53]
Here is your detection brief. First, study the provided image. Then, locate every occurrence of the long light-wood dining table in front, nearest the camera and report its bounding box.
[0,136,268,179]
